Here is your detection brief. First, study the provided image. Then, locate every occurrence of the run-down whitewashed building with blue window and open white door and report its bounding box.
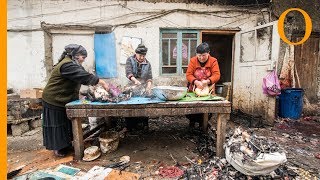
[7,0,320,124]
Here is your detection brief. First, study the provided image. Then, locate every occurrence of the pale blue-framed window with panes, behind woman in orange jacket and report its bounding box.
[160,30,199,75]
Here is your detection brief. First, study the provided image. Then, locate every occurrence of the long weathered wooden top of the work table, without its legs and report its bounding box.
[66,101,231,118]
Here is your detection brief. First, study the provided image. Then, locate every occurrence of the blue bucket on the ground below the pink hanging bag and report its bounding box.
[279,88,304,119]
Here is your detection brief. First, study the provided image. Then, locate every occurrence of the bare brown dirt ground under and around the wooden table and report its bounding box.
[7,114,320,179]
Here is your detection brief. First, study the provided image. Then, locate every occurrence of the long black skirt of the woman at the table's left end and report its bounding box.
[42,101,72,150]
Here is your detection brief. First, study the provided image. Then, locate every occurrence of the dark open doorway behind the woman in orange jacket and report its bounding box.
[202,32,234,85]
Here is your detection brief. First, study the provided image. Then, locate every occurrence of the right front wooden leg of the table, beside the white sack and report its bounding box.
[216,114,230,157]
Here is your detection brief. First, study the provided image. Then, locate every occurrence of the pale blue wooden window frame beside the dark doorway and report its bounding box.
[159,29,200,76]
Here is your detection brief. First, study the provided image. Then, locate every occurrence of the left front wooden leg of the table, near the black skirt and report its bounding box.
[71,118,84,160]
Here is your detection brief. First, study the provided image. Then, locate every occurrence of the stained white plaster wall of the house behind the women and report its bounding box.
[7,0,266,89]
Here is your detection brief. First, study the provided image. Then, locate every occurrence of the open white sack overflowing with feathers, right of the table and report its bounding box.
[225,128,287,176]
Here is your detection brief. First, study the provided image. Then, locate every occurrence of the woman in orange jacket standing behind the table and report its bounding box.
[186,42,220,128]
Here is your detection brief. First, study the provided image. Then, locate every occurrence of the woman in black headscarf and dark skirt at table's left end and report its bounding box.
[42,44,109,156]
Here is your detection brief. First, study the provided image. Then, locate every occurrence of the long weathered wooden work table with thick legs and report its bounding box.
[66,101,231,160]
